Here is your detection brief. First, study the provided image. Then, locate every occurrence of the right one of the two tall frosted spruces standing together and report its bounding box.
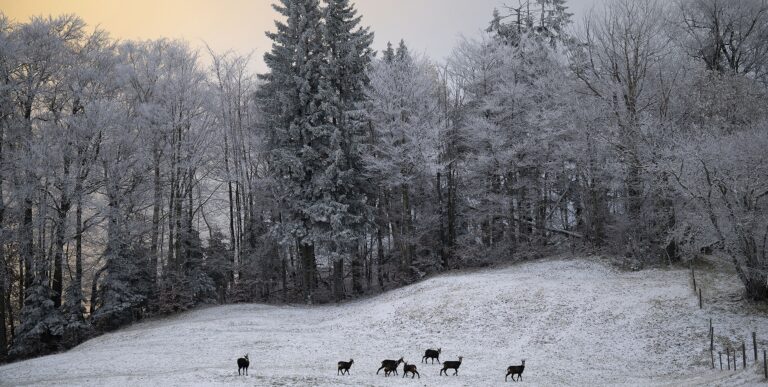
[317,0,373,300]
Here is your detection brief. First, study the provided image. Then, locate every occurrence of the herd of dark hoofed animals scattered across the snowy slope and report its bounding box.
[237,348,525,382]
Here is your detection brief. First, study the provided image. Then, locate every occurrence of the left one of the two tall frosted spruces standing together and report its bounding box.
[259,0,324,303]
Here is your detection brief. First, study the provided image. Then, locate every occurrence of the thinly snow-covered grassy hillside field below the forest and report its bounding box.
[0,259,768,386]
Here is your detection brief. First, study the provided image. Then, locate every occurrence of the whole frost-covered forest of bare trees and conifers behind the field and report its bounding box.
[0,0,768,361]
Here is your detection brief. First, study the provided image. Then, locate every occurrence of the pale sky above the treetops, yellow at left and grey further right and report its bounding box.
[0,0,597,72]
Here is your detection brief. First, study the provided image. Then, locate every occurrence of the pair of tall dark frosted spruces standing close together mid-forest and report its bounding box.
[260,0,373,302]
